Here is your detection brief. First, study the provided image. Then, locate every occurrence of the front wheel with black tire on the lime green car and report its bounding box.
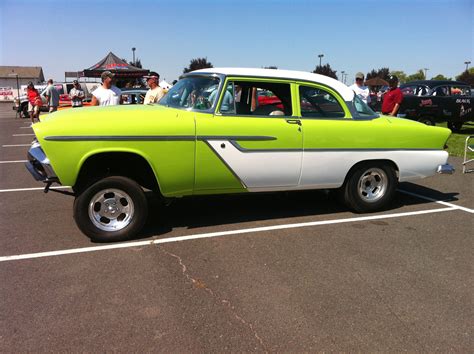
[74,176,148,242]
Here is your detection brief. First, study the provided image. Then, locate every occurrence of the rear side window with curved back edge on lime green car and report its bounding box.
[299,86,345,118]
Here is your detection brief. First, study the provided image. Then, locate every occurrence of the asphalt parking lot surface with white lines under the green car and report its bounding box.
[0,103,474,352]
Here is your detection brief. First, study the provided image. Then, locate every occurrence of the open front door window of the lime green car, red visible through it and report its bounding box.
[219,81,293,116]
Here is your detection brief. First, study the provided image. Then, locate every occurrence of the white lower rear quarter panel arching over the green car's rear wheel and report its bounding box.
[300,150,448,188]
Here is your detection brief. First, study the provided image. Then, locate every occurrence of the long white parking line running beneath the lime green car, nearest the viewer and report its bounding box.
[0,208,457,262]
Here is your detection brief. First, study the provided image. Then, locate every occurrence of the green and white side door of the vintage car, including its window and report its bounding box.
[195,78,303,193]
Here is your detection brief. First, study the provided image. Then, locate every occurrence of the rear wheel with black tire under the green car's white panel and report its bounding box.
[343,162,398,213]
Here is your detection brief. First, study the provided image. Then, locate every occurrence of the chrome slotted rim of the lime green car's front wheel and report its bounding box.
[89,189,135,231]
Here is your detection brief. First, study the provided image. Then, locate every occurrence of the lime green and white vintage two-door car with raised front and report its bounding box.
[27,68,454,241]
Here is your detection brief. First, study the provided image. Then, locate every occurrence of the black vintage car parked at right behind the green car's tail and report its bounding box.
[399,80,474,131]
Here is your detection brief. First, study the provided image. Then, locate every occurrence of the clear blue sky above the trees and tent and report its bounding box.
[0,0,474,84]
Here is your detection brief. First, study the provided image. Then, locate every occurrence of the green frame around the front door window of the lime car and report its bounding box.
[215,75,296,119]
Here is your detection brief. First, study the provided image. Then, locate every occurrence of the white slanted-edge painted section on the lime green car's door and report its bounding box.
[208,140,303,189]
